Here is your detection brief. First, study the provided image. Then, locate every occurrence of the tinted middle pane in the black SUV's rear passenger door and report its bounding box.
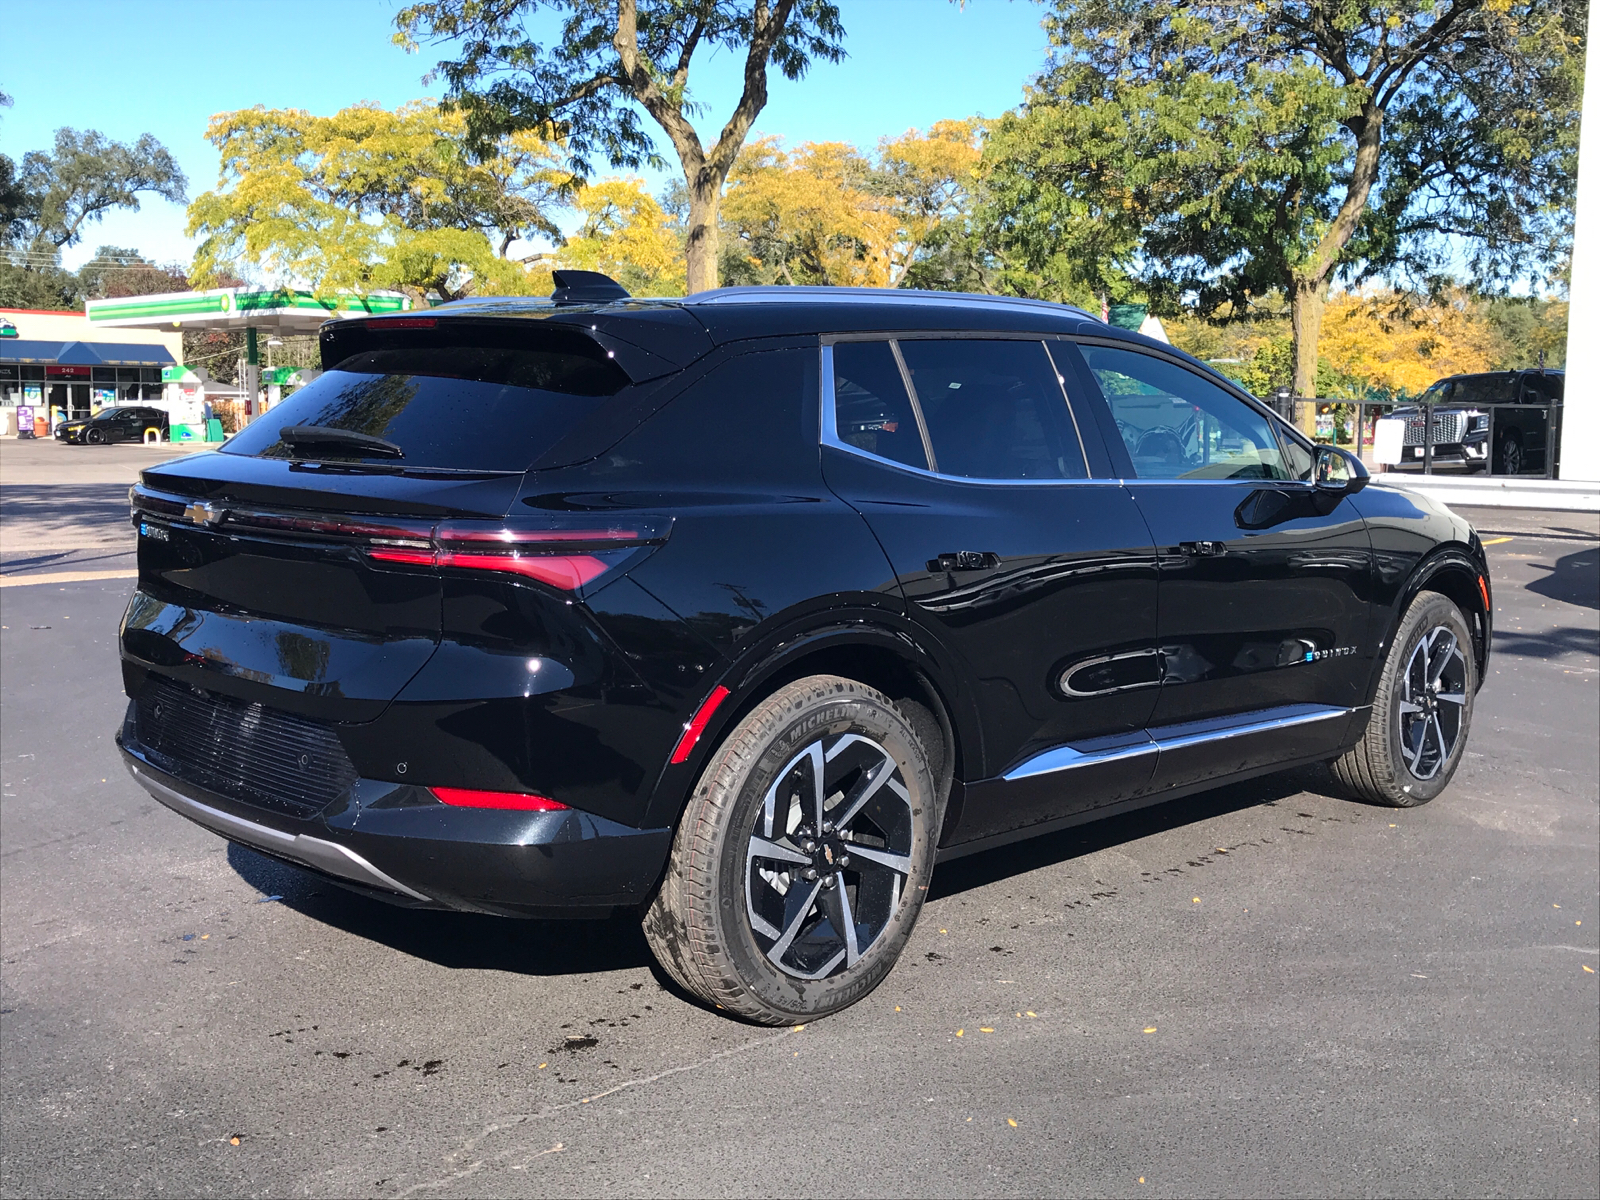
[899,339,1088,480]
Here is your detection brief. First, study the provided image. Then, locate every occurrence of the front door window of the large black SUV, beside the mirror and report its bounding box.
[1078,346,1291,480]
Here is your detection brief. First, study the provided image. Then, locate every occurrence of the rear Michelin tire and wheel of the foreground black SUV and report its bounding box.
[643,675,941,1026]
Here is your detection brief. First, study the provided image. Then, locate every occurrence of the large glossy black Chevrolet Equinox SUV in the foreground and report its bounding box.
[118,278,1490,1022]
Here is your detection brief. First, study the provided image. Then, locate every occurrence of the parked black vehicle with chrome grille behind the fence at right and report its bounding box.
[1392,371,1566,475]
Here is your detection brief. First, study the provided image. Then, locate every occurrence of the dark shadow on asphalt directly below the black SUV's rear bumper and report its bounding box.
[227,845,654,974]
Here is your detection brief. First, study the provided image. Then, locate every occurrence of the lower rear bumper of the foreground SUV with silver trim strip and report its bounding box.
[117,733,672,917]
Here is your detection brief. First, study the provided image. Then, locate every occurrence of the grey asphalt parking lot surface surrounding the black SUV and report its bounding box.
[0,443,1600,1197]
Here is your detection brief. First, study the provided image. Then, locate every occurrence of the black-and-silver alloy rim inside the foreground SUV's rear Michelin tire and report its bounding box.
[744,733,914,979]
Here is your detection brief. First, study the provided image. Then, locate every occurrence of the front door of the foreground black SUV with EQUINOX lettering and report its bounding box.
[1056,341,1376,790]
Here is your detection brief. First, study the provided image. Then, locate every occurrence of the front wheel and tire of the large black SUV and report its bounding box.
[1333,592,1478,808]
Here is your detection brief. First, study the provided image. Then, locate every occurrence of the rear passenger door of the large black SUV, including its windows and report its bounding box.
[822,336,1158,842]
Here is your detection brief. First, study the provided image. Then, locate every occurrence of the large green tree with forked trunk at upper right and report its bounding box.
[986,0,1587,422]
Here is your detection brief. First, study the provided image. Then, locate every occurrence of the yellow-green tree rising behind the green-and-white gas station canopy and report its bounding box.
[189,102,571,299]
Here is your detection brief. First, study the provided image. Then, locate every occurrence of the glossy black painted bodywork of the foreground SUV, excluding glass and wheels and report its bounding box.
[122,291,1490,912]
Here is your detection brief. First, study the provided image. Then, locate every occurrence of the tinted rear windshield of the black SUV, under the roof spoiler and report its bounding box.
[222,329,629,470]
